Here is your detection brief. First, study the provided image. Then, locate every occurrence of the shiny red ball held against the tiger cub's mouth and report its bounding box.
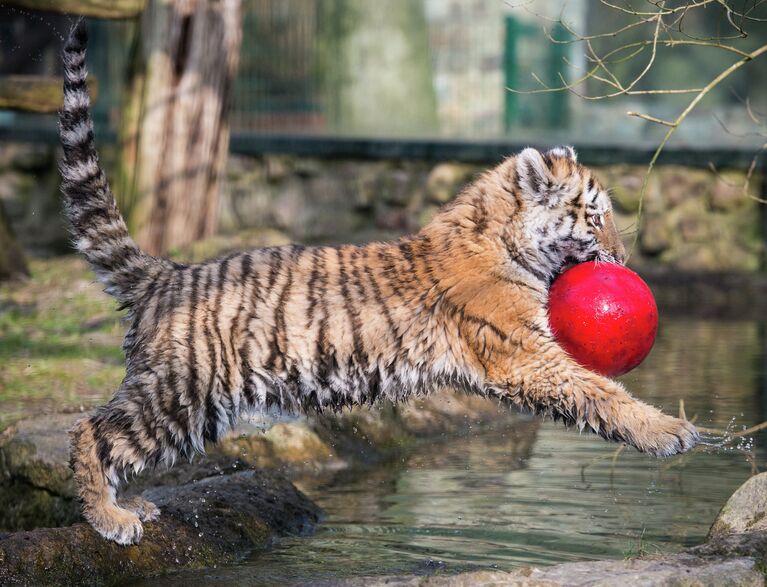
[549,262,658,377]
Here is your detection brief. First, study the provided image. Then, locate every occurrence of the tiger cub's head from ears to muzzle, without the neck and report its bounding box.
[509,147,626,280]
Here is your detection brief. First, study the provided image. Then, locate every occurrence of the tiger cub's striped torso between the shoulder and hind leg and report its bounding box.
[125,239,488,449]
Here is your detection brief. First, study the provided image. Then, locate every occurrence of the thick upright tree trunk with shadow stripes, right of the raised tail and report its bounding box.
[117,0,242,254]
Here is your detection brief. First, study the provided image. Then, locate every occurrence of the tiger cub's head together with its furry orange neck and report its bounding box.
[424,147,626,287]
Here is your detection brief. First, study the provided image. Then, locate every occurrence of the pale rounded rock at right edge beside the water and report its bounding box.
[708,473,767,541]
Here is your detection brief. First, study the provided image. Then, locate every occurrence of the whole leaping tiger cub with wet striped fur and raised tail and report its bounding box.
[60,25,698,544]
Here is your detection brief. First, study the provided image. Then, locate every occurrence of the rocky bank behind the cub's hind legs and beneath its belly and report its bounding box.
[0,390,520,530]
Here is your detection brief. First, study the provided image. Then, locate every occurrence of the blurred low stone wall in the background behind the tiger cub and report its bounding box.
[0,144,764,272]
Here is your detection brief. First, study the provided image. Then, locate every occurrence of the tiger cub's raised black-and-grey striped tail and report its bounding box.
[59,19,168,307]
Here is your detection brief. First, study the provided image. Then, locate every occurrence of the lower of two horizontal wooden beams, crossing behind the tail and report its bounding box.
[0,75,98,113]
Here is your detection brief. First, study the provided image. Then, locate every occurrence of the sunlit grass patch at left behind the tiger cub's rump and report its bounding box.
[0,257,124,429]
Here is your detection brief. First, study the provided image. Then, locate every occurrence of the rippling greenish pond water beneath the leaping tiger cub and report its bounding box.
[142,318,767,587]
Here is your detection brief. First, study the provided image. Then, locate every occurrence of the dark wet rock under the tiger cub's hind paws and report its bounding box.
[0,471,320,585]
